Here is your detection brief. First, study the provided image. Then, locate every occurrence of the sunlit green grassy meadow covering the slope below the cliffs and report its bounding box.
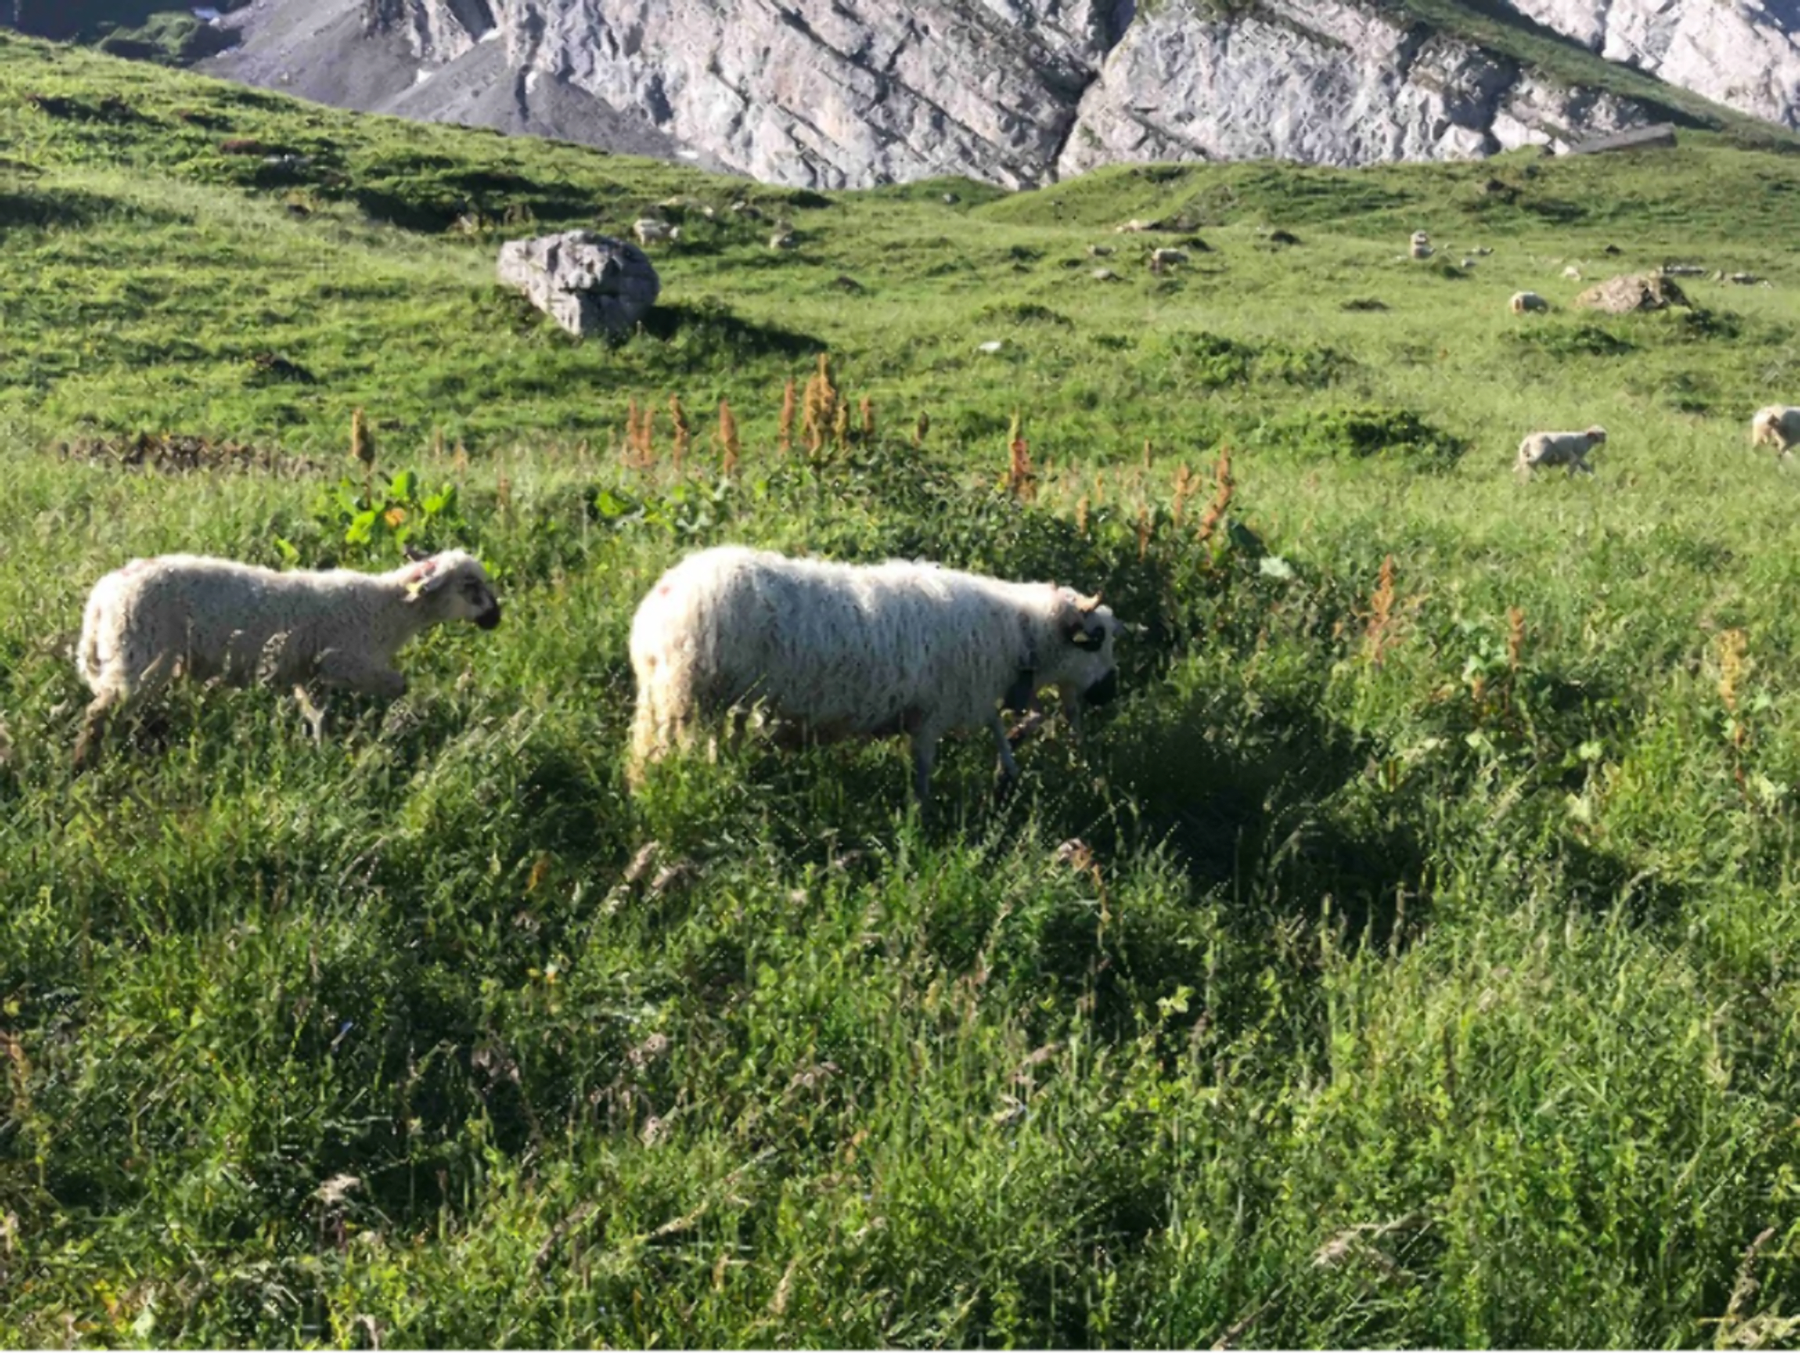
[10,38,1800,1350]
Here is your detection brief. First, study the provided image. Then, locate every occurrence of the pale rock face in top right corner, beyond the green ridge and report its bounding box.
[1505,0,1800,126]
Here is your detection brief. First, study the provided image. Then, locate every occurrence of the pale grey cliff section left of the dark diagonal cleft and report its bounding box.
[369,0,1112,187]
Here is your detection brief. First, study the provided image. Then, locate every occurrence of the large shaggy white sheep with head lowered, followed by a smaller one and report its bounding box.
[630,546,1121,808]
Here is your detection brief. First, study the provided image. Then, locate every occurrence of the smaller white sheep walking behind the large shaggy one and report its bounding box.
[76,551,500,765]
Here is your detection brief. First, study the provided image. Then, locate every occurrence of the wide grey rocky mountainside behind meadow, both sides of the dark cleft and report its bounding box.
[193,0,1771,187]
